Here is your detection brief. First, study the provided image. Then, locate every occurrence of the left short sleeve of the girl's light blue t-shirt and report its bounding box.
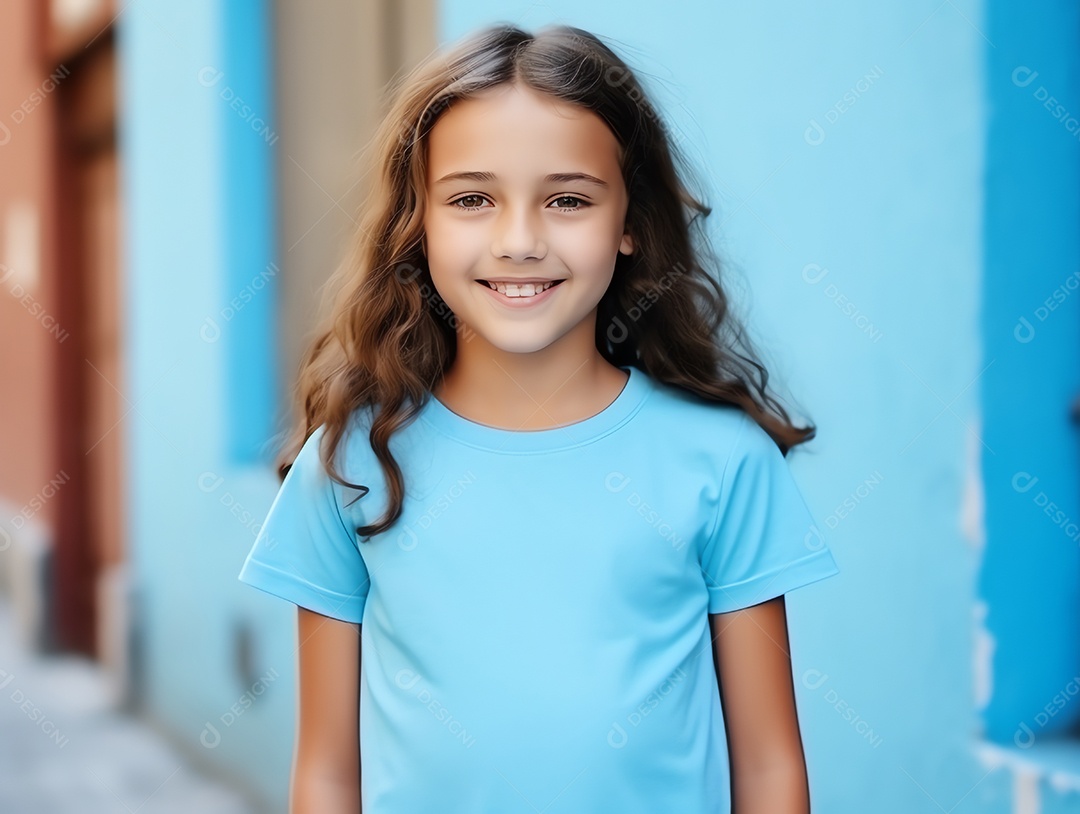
[238,425,369,624]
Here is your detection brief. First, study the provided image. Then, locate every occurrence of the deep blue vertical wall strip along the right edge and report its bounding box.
[980,2,1080,755]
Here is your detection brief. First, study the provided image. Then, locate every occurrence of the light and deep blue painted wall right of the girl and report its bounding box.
[432,0,1080,814]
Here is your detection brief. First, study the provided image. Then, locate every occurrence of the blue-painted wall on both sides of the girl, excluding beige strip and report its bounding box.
[119,0,1080,814]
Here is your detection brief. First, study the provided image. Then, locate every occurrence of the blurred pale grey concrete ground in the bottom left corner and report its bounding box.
[0,596,256,814]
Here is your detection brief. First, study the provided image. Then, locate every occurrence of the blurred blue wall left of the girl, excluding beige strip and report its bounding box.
[118,0,295,808]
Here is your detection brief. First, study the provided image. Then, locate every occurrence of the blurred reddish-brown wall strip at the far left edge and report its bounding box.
[0,0,61,643]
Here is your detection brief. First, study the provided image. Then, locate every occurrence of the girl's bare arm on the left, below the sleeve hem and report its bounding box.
[288,606,361,814]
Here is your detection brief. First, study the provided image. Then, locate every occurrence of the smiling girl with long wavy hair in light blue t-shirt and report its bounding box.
[240,26,838,814]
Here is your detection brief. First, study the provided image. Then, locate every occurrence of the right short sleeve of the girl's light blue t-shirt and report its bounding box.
[701,413,839,613]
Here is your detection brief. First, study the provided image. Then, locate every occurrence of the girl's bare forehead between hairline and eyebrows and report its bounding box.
[428,85,619,182]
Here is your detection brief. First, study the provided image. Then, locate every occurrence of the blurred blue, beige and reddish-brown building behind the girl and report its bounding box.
[0,0,1080,814]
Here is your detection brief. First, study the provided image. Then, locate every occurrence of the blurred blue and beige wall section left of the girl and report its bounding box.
[119,0,434,812]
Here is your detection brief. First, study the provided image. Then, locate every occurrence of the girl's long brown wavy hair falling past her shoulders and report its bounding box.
[279,24,816,538]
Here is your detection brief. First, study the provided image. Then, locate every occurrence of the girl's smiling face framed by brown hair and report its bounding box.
[423,85,633,353]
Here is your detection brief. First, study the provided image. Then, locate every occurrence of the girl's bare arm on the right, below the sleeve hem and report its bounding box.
[708,595,810,814]
